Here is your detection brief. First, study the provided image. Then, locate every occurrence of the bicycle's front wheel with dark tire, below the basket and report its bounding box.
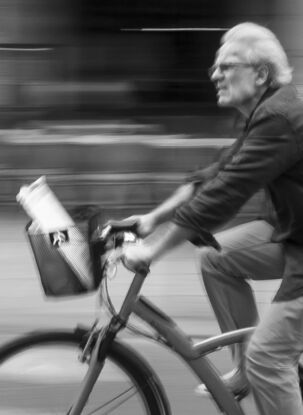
[0,329,171,415]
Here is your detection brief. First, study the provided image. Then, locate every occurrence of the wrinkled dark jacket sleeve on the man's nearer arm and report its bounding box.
[173,114,300,237]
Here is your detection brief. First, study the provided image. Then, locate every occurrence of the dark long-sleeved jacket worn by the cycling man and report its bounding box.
[174,85,303,245]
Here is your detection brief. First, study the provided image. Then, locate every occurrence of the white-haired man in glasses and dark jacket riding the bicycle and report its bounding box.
[123,23,303,415]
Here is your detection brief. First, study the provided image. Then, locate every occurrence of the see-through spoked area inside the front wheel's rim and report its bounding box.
[0,346,144,415]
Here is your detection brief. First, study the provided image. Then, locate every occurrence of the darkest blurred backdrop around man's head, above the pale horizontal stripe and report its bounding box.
[0,0,303,128]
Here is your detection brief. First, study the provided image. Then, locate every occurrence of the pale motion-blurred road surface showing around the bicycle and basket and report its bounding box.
[0,211,273,415]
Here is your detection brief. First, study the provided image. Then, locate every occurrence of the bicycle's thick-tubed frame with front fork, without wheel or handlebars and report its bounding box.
[69,272,254,415]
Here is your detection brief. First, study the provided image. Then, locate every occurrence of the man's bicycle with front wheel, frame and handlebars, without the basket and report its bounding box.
[0,221,301,415]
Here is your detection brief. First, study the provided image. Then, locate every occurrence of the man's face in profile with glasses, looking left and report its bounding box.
[210,43,260,113]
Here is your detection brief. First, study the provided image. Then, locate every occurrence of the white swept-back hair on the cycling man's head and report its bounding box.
[221,22,293,87]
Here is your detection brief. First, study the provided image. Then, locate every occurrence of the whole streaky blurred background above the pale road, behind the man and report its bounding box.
[0,0,303,214]
